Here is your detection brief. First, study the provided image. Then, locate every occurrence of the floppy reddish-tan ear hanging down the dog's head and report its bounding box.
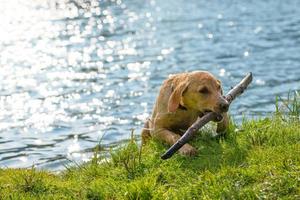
[168,82,188,112]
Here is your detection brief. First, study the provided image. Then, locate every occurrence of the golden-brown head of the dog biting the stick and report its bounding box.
[168,71,229,113]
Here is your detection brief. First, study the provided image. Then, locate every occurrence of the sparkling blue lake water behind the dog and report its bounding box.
[0,0,300,170]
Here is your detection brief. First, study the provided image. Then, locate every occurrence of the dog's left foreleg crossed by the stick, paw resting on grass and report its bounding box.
[152,128,197,156]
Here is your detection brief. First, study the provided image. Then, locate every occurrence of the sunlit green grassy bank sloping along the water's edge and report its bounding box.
[0,95,300,199]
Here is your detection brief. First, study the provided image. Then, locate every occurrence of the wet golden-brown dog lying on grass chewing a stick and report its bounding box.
[142,71,229,156]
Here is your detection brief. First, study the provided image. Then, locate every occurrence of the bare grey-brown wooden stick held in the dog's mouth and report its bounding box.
[161,72,252,160]
